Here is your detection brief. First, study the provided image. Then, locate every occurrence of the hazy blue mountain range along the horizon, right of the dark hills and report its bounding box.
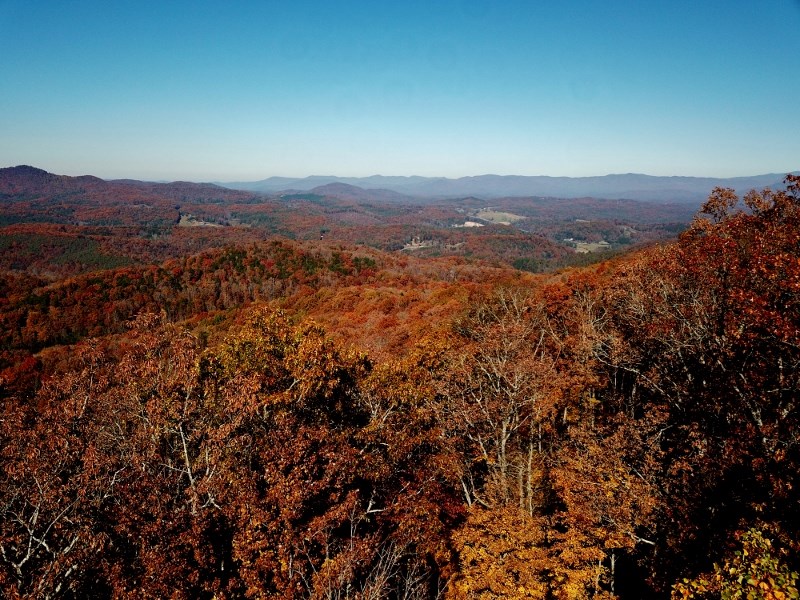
[225,173,786,203]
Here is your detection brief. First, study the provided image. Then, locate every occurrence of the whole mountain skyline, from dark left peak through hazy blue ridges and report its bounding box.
[0,166,800,204]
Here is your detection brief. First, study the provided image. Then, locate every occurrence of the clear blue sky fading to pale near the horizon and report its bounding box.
[0,0,800,181]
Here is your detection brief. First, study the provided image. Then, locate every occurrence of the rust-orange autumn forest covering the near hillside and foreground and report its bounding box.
[0,175,800,600]
